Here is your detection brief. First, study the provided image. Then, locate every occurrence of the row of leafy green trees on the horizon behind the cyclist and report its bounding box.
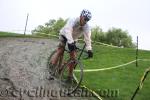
[32,18,135,48]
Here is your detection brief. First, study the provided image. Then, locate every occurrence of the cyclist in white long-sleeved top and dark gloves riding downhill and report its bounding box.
[51,9,93,81]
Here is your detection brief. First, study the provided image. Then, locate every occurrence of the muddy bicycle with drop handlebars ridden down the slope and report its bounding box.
[48,44,87,94]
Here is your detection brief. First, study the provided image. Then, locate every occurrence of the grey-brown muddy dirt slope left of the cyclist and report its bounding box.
[0,37,95,100]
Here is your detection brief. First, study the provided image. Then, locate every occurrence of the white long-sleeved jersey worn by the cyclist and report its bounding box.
[60,17,92,50]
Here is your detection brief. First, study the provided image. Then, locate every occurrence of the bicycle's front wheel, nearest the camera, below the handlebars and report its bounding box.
[59,60,83,95]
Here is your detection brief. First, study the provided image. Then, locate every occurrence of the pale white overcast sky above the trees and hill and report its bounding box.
[0,0,150,50]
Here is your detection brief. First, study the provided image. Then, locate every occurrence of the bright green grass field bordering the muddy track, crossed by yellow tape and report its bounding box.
[0,32,150,100]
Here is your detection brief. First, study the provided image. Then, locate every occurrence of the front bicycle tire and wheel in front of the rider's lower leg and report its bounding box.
[59,60,83,95]
